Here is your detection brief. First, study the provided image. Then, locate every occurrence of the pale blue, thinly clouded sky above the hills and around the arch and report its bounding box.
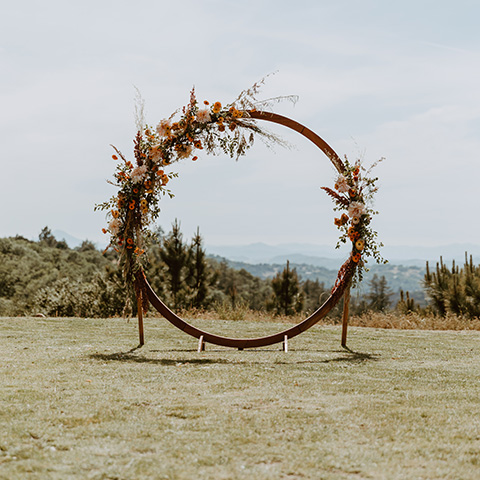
[0,0,480,248]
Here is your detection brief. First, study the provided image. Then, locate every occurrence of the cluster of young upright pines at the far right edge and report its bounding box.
[424,254,480,318]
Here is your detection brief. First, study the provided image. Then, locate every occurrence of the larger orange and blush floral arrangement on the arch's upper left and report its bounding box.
[95,79,297,292]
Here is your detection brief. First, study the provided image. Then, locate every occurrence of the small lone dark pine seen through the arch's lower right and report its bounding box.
[272,260,304,315]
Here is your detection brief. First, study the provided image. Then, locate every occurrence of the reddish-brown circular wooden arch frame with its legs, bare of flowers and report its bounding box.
[136,110,356,350]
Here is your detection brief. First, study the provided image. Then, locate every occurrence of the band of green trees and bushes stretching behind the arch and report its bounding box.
[0,221,480,318]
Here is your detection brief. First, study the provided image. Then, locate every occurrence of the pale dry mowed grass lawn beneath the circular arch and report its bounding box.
[0,318,480,480]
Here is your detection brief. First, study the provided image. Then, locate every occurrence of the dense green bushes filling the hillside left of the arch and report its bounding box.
[0,227,125,317]
